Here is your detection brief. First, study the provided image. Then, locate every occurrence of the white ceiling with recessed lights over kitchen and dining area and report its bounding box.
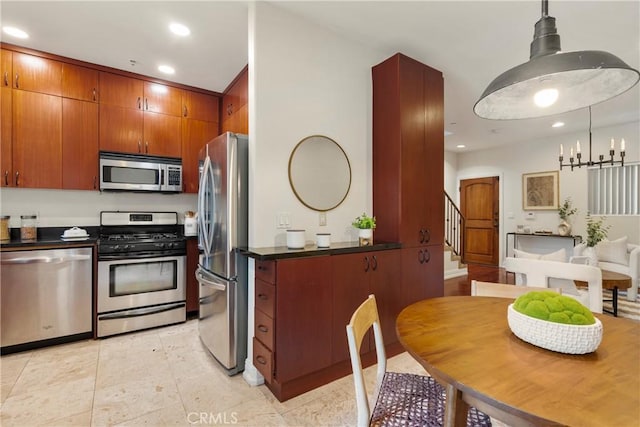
[0,0,640,152]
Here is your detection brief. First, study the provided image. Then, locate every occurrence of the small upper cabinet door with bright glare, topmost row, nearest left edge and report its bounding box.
[13,52,62,96]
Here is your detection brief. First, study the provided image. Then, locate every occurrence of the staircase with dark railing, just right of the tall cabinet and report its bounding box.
[444,191,467,280]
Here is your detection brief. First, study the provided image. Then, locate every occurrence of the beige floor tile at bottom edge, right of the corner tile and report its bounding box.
[91,373,181,426]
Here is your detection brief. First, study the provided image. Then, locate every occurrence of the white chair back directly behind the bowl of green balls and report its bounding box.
[504,257,602,313]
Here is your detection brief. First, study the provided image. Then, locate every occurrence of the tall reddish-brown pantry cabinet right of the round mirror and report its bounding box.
[372,53,444,305]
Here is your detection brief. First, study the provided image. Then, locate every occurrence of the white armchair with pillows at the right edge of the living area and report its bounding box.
[573,237,640,301]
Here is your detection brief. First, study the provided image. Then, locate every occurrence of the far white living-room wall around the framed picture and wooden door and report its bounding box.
[456,122,640,256]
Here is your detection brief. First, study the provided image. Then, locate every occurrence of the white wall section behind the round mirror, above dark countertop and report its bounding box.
[249,2,385,247]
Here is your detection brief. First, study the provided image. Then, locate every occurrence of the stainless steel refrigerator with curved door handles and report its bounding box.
[196,132,249,375]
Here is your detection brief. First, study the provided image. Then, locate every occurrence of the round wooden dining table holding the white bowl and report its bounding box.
[396,296,640,427]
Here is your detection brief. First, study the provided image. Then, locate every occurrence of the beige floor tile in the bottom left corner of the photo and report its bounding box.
[1,377,95,427]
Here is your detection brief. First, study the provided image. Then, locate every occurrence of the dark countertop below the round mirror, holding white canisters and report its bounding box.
[238,242,402,261]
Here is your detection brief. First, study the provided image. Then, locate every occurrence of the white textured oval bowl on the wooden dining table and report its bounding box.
[507,304,602,354]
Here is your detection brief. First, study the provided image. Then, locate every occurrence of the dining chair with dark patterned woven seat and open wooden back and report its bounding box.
[347,295,491,427]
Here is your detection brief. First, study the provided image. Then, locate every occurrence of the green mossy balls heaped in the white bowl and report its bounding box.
[513,291,596,325]
